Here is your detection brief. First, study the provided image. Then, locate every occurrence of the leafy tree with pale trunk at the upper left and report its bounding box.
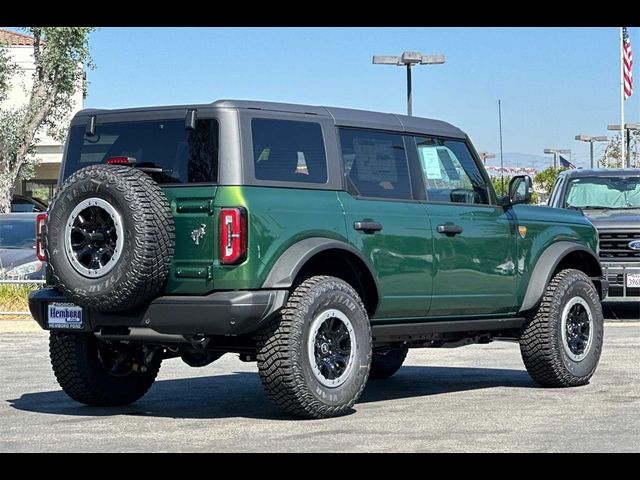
[0,27,95,213]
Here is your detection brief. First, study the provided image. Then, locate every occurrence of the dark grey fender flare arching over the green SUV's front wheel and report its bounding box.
[520,241,600,312]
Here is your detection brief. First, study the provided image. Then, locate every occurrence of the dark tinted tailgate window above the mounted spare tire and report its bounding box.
[64,119,218,183]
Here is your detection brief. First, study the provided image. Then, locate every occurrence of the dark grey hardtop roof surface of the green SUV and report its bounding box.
[76,100,466,138]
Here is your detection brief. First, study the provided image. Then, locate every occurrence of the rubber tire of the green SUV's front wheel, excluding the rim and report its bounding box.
[520,269,604,387]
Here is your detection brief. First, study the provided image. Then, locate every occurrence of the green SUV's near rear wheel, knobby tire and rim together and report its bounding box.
[257,276,371,418]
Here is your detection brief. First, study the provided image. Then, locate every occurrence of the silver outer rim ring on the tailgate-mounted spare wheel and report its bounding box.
[64,197,124,278]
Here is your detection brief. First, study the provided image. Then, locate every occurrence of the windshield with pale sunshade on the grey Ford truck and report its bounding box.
[566,176,640,208]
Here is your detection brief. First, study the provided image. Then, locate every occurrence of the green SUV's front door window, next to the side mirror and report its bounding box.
[416,137,489,204]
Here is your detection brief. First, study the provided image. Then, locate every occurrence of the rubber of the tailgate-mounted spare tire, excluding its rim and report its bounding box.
[46,165,174,312]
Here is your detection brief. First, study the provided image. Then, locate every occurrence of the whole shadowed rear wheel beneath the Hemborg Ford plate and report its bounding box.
[49,332,162,407]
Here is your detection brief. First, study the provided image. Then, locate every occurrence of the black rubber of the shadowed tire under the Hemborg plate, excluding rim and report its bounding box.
[49,332,162,407]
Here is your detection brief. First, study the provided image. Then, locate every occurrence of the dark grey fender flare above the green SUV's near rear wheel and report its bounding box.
[262,237,380,292]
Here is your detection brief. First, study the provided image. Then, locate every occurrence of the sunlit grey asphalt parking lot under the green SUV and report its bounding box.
[0,306,640,452]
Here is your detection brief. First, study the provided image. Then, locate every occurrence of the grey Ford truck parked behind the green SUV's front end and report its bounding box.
[549,168,640,301]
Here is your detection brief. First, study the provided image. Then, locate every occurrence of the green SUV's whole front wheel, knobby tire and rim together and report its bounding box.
[520,269,604,387]
